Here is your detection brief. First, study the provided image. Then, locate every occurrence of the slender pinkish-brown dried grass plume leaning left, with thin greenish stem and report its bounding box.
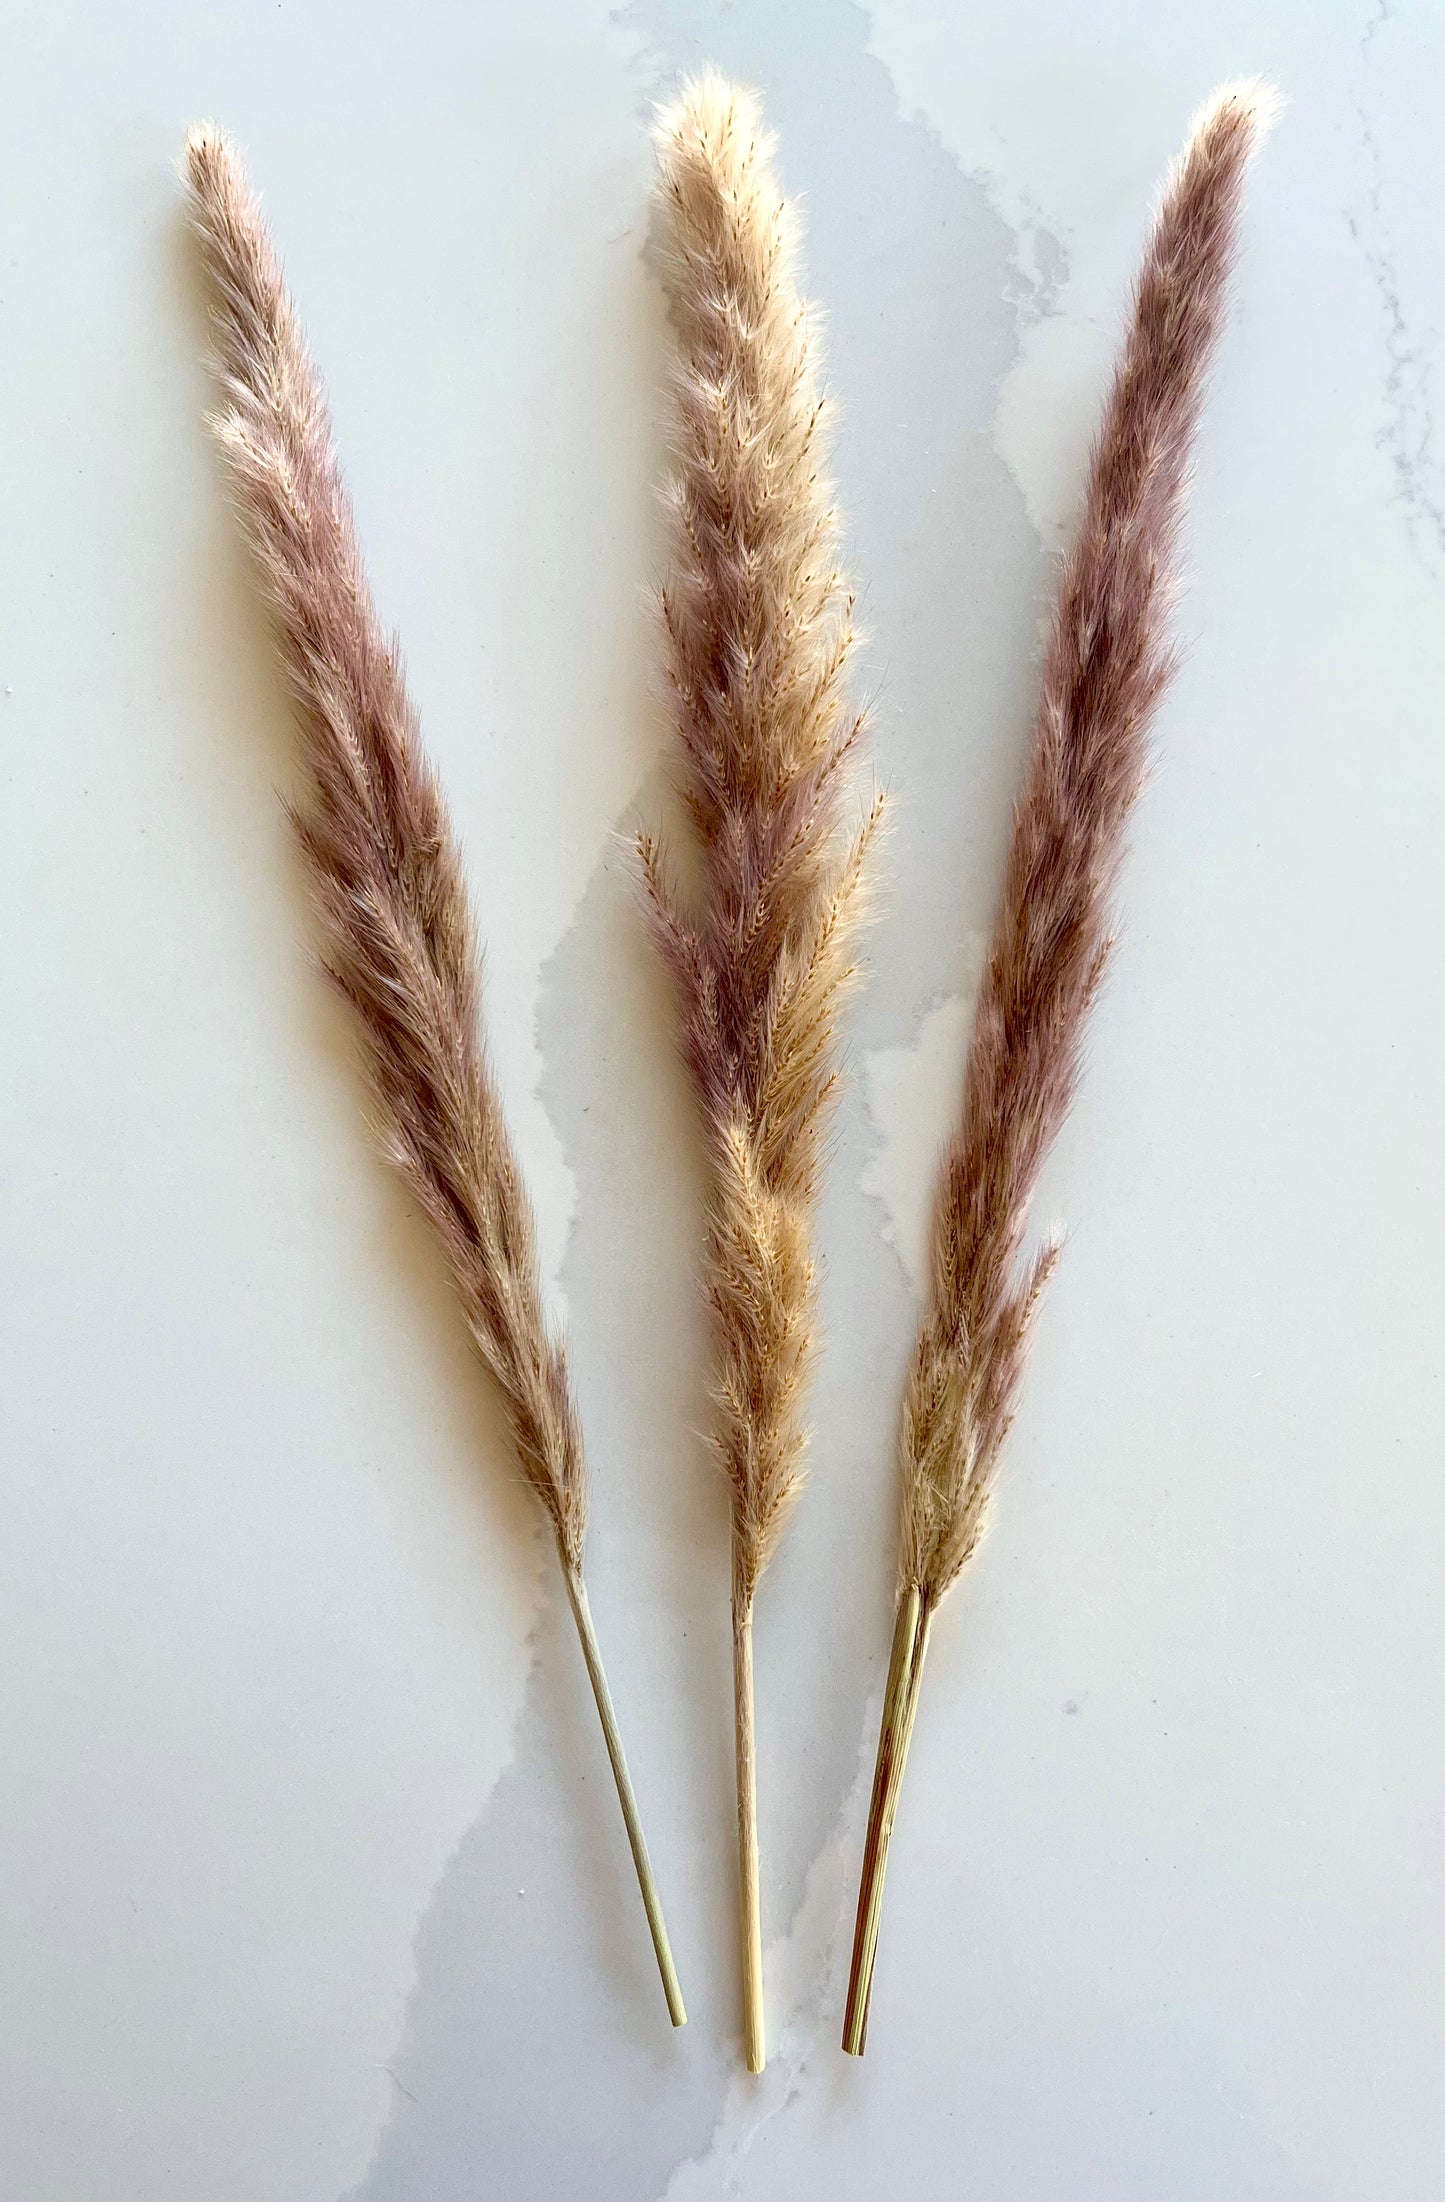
[185,128,685,2026]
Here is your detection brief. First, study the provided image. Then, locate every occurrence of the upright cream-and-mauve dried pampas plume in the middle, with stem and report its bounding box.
[639,77,881,2072]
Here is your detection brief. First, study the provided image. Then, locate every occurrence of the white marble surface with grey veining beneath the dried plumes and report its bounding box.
[0,0,1445,2202]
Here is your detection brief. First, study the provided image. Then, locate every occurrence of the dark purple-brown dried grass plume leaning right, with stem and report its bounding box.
[844,86,1271,2057]
